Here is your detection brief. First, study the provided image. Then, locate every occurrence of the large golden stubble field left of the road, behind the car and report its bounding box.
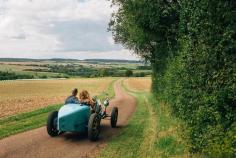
[0,78,114,118]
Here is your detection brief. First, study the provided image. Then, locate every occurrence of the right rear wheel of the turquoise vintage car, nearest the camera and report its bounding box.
[88,113,101,141]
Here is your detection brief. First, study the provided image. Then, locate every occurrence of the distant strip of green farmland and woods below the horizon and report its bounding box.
[0,58,151,80]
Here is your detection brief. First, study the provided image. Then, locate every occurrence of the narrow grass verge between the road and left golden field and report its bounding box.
[0,78,117,139]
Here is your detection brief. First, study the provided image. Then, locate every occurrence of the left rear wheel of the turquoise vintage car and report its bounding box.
[47,111,59,137]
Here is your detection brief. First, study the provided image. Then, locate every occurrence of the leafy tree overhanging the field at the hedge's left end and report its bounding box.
[109,0,180,92]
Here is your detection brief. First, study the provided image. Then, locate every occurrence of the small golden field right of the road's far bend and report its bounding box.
[124,77,152,92]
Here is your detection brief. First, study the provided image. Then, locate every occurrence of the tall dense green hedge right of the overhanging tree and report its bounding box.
[164,0,236,157]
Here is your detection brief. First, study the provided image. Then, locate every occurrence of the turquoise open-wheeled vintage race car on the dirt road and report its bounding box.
[47,97,118,141]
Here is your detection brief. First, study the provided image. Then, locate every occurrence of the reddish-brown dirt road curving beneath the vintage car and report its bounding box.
[0,80,136,158]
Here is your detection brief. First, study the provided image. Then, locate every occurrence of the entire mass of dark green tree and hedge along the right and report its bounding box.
[110,0,236,157]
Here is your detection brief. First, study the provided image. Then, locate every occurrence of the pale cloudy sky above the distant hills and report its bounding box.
[0,0,138,60]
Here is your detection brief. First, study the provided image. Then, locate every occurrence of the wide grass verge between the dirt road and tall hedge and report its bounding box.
[99,79,190,158]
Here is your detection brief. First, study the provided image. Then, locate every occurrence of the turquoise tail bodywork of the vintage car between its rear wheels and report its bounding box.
[58,104,90,132]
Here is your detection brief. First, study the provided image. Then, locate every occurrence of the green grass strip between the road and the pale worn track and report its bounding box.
[100,92,148,158]
